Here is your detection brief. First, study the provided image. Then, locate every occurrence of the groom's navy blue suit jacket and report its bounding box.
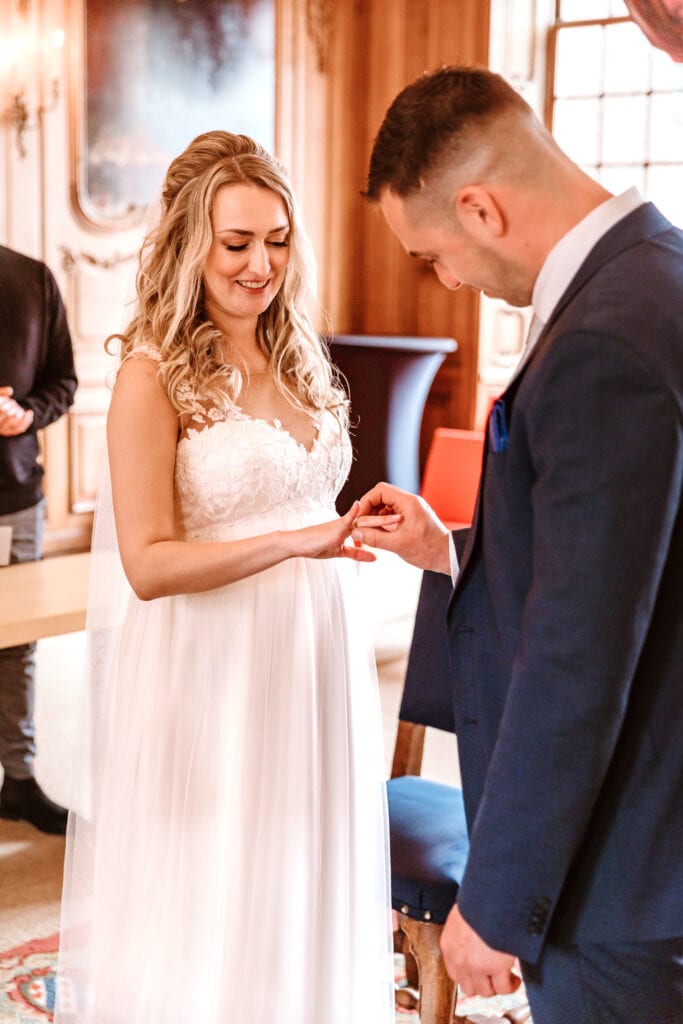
[449,204,683,962]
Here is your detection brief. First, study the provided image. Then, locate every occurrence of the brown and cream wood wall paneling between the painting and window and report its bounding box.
[278,0,488,462]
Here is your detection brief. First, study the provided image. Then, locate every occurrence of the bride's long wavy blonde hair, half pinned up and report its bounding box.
[113,131,348,424]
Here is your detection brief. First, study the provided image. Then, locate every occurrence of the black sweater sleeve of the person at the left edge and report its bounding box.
[22,267,78,431]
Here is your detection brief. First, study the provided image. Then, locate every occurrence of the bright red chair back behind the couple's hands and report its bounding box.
[420,427,484,529]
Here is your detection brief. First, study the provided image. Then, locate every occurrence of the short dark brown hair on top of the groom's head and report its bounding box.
[364,65,532,203]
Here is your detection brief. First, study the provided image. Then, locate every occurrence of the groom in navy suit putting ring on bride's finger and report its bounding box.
[354,68,683,1024]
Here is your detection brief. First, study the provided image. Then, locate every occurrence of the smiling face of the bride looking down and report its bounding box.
[204,184,290,319]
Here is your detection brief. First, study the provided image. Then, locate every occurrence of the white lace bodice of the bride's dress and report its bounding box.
[175,409,351,540]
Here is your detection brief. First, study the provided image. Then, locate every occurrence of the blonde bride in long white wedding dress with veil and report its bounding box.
[55,131,397,1024]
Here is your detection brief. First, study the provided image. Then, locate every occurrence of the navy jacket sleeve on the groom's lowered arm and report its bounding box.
[459,334,683,962]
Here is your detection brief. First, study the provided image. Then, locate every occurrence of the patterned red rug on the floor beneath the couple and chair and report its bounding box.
[0,935,530,1024]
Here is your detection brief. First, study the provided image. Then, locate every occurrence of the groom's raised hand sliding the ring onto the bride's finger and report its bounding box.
[351,483,451,573]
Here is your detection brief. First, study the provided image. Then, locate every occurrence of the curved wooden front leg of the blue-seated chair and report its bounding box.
[398,913,458,1024]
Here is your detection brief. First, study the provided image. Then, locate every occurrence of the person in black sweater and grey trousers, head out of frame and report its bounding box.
[0,246,78,834]
